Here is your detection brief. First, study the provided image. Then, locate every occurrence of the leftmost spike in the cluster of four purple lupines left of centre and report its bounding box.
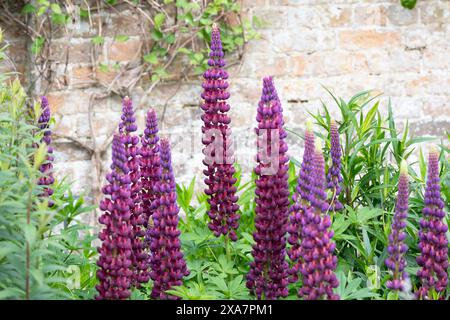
[96,135,134,300]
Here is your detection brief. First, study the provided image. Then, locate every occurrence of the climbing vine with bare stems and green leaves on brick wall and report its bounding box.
[0,0,261,216]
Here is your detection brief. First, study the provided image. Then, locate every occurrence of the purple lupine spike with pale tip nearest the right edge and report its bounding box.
[416,150,448,299]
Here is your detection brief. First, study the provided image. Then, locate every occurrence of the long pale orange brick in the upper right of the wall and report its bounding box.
[339,30,400,50]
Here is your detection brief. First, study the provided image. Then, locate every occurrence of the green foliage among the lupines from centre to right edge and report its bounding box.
[158,92,450,300]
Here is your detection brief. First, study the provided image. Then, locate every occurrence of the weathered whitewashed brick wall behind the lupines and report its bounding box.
[0,0,450,200]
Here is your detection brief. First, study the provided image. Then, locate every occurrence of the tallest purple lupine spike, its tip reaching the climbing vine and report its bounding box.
[201,25,239,241]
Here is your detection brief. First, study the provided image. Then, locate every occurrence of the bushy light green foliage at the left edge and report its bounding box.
[0,60,96,299]
